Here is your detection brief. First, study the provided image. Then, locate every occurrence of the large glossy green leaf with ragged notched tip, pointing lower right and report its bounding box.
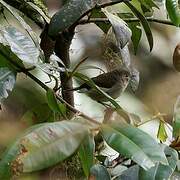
[101,123,167,170]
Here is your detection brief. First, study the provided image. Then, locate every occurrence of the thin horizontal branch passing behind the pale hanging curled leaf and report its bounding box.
[78,17,175,26]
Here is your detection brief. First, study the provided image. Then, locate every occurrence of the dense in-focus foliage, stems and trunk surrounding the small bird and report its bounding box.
[0,0,180,180]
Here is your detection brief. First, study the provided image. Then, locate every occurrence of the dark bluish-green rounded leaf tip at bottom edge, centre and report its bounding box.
[89,164,111,180]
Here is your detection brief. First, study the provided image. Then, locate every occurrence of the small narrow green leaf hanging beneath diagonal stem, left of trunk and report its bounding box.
[46,88,66,116]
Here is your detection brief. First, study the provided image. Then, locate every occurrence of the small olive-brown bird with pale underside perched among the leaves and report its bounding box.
[71,67,131,102]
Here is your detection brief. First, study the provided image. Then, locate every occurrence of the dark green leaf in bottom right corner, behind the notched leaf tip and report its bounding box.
[139,146,178,180]
